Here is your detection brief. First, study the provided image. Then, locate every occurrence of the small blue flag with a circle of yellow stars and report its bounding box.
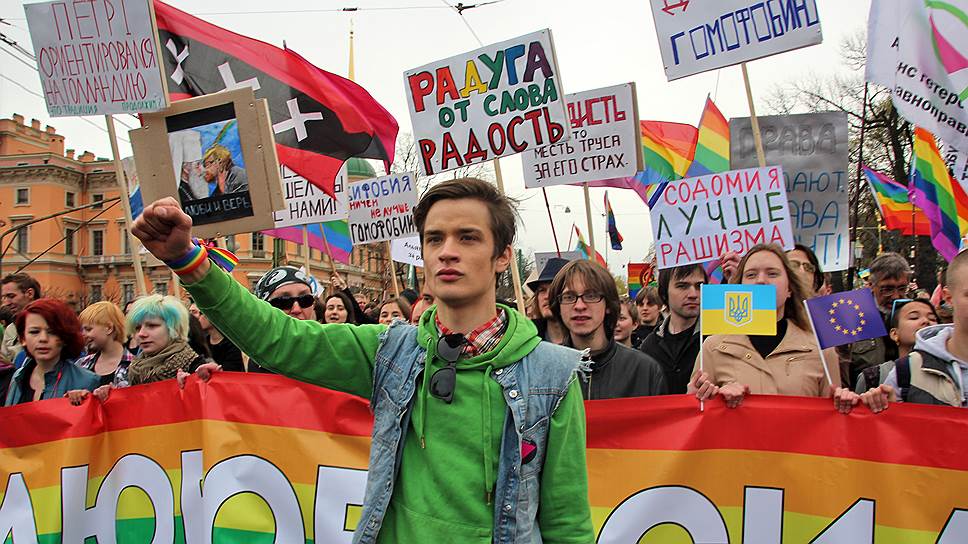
[807,289,887,349]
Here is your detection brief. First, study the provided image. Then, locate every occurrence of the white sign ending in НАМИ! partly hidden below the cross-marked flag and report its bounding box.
[272,164,347,229]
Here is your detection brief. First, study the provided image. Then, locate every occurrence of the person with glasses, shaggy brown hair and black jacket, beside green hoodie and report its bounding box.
[548,259,666,400]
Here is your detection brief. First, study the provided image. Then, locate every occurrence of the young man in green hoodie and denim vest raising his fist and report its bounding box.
[132,179,594,544]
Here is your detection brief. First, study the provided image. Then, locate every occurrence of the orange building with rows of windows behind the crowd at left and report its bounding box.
[0,114,392,309]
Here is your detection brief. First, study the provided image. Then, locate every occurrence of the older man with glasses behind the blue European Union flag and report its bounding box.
[849,253,911,388]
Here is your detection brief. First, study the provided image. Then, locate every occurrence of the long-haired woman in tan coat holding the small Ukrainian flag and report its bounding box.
[689,244,840,408]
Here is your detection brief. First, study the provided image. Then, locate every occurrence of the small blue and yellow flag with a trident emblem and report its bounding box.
[700,284,776,336]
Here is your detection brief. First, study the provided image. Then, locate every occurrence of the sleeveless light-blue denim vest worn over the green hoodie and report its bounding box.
[353,323,581,544]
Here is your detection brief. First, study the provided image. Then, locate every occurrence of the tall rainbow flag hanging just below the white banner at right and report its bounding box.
[911,127,968,262]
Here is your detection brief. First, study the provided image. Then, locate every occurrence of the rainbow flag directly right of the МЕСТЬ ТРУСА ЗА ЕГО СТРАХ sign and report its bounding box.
[588,121,699,208]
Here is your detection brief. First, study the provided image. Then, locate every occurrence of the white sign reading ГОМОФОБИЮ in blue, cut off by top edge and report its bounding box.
[650,0,823,81]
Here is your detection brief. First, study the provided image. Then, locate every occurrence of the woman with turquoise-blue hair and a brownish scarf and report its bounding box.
[127,295,206,385]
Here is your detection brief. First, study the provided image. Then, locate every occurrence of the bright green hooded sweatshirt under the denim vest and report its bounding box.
[186,266,594,544]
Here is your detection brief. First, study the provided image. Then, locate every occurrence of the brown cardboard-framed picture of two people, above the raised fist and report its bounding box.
[128,87,285,238]
